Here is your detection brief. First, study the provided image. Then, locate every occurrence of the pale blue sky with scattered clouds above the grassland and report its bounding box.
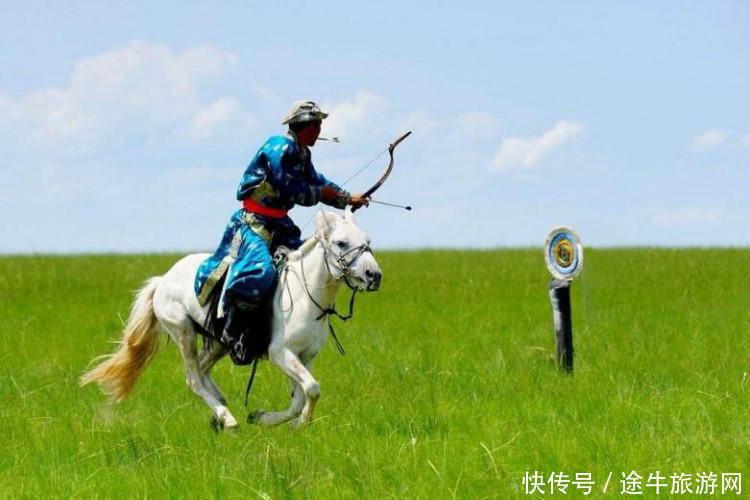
[0,0,750,254]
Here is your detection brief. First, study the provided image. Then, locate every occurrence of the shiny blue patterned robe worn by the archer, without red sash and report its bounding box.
[194,132,348,315]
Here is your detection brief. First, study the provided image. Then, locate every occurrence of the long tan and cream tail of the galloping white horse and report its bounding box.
[79,277,161,403]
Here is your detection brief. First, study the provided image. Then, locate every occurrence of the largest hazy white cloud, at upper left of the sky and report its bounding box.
[0,40,237,152]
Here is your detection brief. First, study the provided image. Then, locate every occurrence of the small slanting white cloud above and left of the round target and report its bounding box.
[492,121,583,171]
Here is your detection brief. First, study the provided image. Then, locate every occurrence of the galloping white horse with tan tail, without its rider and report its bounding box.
[80,210,382,428]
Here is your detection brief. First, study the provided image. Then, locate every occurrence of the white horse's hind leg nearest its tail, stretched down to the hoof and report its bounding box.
[162,322,237,428]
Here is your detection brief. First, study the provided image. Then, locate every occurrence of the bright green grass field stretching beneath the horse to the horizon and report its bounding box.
[0,249,750,498]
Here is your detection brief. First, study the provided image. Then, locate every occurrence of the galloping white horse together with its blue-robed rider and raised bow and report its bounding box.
[80,101,411,428]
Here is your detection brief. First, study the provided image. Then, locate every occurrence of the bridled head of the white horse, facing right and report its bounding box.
[316,209,383,292]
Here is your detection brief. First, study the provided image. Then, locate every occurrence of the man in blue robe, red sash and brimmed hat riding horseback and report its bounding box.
[194,101,368,364]
